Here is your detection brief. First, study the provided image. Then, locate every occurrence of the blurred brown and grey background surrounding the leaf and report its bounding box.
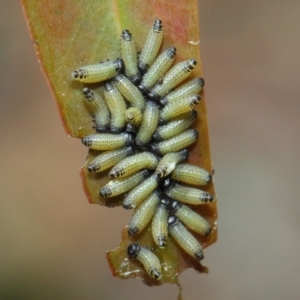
[0,0,300,300]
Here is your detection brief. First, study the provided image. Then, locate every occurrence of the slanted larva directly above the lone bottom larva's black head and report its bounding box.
[128,190,161,235]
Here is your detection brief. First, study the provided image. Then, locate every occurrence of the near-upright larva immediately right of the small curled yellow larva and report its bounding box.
[135,101,159,149]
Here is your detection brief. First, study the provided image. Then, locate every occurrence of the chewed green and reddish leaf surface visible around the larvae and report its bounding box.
[23,0,217,285]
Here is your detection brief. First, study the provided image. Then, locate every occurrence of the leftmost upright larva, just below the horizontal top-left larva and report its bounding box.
[83,88,110,132]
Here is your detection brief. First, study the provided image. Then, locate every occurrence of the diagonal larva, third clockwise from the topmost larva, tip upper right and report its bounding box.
[148,59,197,102]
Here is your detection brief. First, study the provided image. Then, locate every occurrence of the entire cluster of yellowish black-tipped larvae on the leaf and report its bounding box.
[72,20,214,280]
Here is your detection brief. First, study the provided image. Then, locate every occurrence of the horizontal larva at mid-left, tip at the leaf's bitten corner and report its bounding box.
[81,132,134,150]
